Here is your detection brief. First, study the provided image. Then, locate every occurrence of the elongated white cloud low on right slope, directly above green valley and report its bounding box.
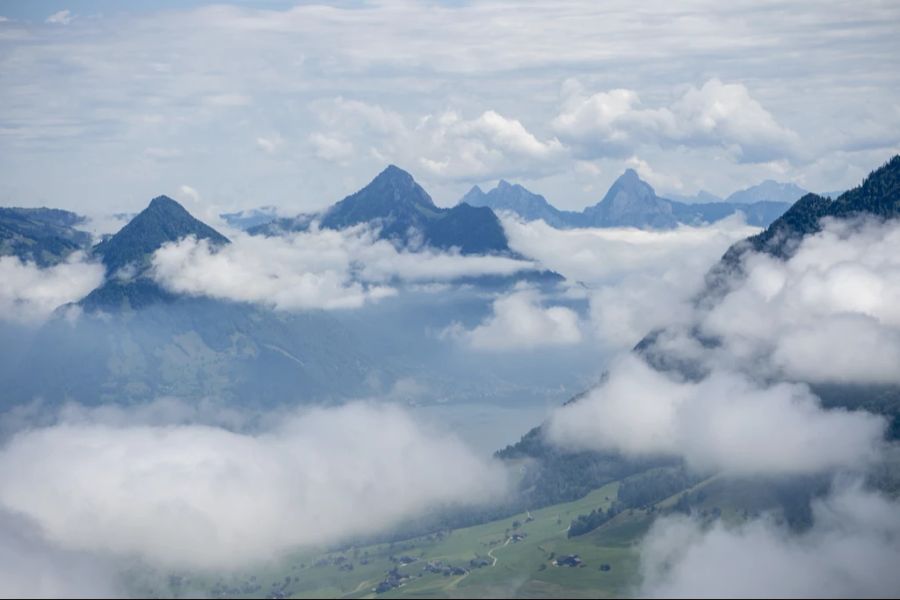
[547,355,885,475]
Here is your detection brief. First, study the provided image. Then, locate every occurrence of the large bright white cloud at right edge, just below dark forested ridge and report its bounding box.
[698,221,900,383]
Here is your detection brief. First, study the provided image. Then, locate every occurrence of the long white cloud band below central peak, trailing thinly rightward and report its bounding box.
[153,226,533,310]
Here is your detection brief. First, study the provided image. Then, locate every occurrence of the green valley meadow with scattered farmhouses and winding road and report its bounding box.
[135,482,650,598]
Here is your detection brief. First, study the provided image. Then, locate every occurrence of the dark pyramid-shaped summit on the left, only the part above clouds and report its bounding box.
[93,196,229,275]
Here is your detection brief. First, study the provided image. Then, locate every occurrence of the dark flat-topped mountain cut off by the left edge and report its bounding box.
[0,208,91,267]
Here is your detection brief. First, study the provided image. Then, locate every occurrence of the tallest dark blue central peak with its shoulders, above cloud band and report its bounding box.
[248,165,509,254]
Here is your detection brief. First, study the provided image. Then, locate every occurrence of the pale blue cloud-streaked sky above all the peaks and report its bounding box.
[0,0,900,218]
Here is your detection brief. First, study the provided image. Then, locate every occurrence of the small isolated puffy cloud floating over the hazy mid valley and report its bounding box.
[448,290,582,351]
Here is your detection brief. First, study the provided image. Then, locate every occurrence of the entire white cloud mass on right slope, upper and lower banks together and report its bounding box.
[548,221,900,475]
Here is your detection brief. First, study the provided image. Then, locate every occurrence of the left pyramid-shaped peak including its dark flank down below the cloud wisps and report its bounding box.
[79,196,230,312]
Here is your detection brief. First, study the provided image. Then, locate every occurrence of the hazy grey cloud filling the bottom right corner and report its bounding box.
[638,486,900,598]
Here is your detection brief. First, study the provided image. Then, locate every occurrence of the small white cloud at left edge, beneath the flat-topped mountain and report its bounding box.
[0,252,104,323]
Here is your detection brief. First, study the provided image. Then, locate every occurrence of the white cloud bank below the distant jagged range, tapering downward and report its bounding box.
[502,216,758,349]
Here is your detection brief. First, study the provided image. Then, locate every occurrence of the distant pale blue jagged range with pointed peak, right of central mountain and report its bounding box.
[460,169,802,229]
